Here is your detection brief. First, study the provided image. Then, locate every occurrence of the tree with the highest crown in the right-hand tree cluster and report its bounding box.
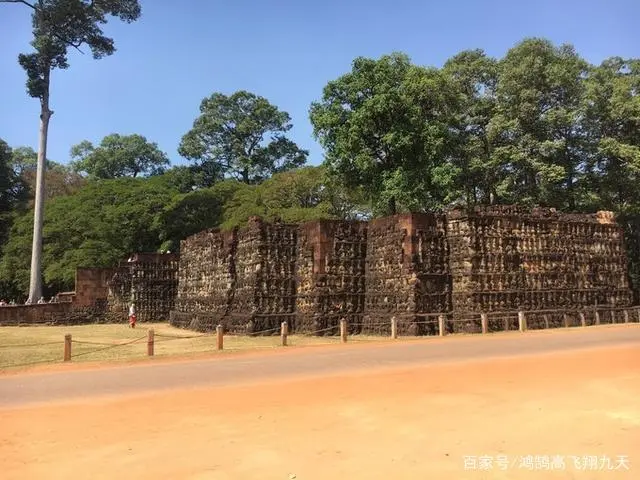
[488,38,589,210]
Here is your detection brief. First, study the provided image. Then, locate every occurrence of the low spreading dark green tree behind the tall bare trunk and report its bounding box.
[0,178,178,292]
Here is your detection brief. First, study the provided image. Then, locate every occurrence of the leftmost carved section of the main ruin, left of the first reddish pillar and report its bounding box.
[171,218,298,334]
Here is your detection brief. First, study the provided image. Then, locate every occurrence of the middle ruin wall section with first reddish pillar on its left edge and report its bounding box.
[294,220,367,335]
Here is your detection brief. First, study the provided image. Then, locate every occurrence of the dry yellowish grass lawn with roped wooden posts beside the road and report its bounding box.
[0,323,390,371]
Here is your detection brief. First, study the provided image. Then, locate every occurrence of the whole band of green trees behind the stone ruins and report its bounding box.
[0,39,640,296]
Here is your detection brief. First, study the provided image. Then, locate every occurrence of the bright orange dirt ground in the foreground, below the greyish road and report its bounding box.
[0,347,640,480]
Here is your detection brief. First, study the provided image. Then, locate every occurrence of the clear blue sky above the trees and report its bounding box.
[0,0,640,168]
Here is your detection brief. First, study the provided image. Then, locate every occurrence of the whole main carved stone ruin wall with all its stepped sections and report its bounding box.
[171,207,631,335]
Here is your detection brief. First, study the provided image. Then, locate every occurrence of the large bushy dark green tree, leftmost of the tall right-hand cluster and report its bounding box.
[310,53,459,213]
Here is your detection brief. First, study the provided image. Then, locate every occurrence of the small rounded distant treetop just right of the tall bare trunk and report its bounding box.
[71,133,169,179]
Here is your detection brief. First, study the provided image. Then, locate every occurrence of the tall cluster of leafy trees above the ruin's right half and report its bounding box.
[310,39,640,213]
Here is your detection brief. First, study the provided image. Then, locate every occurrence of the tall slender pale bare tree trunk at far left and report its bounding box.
[29,68,53,303]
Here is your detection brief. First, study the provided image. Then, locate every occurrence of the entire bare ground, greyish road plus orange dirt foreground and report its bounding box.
[0,326,640,480]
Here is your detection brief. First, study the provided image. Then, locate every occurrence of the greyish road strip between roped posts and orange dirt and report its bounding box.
[0,324,640,406]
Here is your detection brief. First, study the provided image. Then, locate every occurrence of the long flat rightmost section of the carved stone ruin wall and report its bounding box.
[447,206,632,328]
